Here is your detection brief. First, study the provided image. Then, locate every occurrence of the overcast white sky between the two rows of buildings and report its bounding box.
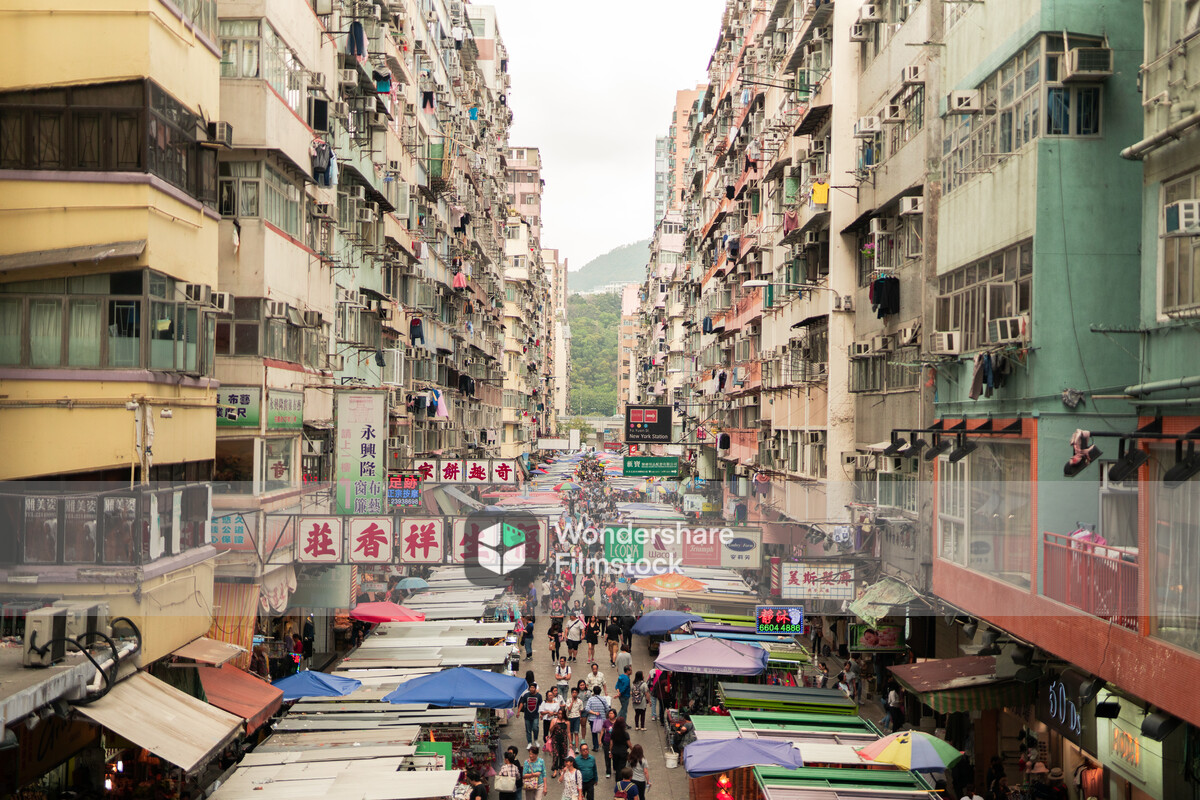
[478,0,725,270]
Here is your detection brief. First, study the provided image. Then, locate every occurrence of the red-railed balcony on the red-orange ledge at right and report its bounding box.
[1042,533,1138,631]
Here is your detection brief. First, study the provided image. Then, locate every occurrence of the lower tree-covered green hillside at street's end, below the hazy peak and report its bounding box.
[566,294,620,416]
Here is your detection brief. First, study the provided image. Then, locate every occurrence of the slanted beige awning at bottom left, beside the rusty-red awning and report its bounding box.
[76,673,241,771]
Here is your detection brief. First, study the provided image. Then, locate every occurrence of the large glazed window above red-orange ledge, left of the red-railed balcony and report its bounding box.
[937,439,1032,588]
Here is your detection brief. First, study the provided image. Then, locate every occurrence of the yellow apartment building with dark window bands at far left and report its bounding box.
[0,0,226,671]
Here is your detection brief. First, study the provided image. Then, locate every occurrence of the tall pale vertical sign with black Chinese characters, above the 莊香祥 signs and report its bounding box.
[336,391,388,515]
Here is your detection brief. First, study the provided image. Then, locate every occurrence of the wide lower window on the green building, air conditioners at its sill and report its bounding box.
[935,240,1033,350]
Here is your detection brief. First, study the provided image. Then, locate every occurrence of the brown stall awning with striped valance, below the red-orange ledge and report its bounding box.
[889,656,1037,714]
